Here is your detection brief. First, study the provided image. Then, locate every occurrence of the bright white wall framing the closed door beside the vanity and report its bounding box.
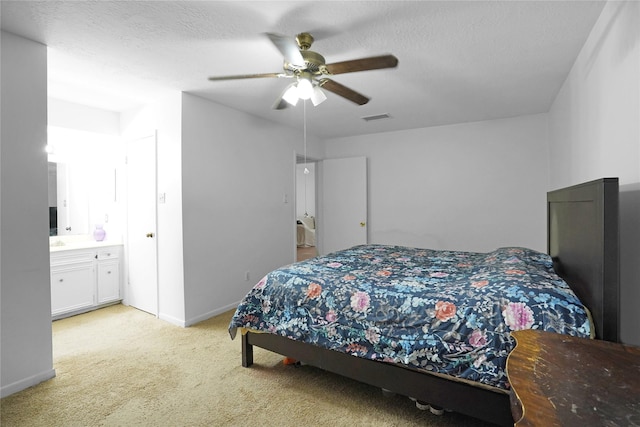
[121,92,187,326]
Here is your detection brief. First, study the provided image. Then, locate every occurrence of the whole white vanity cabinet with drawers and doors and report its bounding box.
[50,245,122,319]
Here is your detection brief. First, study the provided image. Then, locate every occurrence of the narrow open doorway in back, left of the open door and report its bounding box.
[296,156,318,261]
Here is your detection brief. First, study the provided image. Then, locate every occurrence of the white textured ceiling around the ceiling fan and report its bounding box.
[0,0,604,138]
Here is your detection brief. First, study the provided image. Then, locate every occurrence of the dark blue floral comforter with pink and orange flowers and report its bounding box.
[229,245,591,389]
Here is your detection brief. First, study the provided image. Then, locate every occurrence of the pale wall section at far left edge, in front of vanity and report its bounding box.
[0,32,55,396]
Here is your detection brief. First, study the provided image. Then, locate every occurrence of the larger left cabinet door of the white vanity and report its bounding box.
[51,263,96,316]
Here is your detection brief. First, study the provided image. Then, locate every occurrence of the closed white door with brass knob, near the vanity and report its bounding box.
[126,135,158,316]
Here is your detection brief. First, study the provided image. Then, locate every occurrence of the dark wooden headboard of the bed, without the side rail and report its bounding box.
[547,178,620,342]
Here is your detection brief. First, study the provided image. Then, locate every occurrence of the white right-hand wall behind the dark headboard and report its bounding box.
[549,1,640,345]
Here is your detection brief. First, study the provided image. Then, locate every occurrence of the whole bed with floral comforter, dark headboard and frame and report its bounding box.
[229,178,618,425]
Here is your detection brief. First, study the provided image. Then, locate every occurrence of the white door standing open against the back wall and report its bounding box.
[320,157,367,254]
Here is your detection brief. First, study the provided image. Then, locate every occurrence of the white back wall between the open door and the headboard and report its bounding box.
[325,114,549,252]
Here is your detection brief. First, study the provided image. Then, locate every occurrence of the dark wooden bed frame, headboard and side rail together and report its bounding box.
[242,178,619,426]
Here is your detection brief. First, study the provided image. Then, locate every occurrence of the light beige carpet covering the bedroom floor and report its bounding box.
[0,305,496,427]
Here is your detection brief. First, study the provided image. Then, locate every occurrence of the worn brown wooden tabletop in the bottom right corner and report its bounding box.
[507,330,640,427]
